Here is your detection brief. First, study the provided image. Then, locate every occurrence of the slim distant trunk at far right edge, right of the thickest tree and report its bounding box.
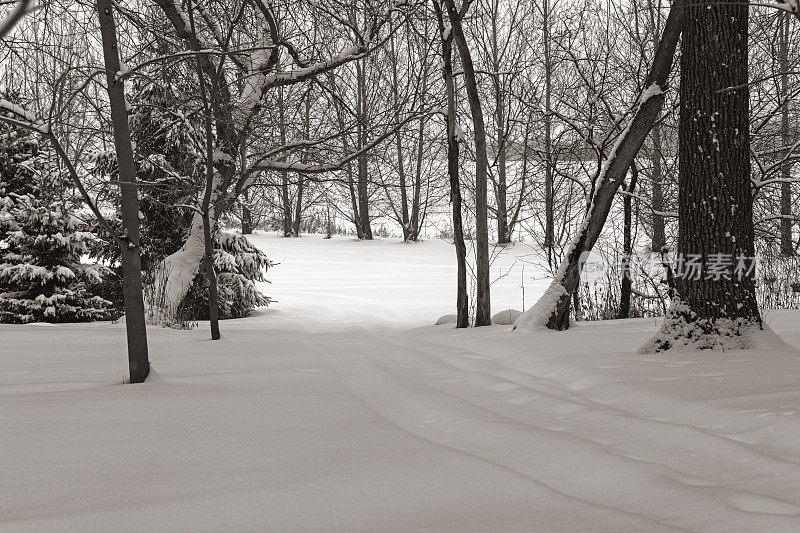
[778,13,794,257]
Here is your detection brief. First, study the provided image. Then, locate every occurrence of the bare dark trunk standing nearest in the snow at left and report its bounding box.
[97,0,150,383]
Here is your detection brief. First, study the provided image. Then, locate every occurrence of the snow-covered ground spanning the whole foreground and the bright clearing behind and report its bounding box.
[0,235,800,532]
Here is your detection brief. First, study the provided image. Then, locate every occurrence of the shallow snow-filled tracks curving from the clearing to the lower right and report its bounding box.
[318,330,800,531]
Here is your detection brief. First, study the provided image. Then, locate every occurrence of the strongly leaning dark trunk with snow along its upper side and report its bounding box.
[514,0,684,330]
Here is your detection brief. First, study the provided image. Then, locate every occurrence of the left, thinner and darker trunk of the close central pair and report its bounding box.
[433,0,469,328]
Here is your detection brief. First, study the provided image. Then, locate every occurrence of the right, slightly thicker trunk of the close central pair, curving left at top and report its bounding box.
[445,0,492,326]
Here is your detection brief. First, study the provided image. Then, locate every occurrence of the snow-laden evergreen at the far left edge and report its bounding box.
[0,95,112,323]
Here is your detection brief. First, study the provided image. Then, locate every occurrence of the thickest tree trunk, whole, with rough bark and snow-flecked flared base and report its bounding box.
[646,0,761,351]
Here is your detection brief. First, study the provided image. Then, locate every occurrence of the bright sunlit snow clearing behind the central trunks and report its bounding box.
[251,233,549,328]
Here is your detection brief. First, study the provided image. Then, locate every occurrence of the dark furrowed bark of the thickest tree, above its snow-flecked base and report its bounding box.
[676,0,760,321]
